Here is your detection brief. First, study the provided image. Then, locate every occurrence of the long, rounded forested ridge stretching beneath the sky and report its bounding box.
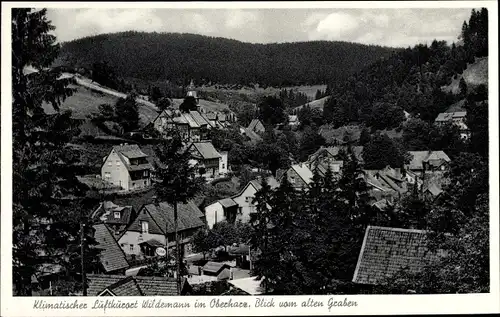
[56,31,394,86]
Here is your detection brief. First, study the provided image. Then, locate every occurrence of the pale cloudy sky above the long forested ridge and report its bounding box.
[47,8,471,47]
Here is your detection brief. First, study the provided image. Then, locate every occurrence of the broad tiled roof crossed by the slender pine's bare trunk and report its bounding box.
[144,201,204,233]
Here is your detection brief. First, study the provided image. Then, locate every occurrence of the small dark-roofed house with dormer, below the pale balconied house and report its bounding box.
[91,201,135,237]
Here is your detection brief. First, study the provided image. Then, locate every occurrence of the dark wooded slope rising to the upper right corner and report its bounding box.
[324,9,488,129]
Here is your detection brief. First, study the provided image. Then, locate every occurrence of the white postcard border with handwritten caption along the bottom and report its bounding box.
[0,1,500,316]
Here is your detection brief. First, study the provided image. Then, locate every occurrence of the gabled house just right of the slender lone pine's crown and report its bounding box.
[187,142,222,179]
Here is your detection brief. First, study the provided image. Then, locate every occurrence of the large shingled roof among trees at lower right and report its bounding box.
[353,226,435,284]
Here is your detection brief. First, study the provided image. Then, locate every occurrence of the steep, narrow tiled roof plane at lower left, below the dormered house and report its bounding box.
[94,224,129,272]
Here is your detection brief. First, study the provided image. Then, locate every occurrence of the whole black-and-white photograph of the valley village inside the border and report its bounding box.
[1,2,498,314]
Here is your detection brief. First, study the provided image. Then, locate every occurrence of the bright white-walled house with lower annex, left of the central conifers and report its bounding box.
[205,177,279,228]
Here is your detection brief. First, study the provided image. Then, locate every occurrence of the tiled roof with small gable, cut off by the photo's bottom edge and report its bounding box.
[87,274,192,296]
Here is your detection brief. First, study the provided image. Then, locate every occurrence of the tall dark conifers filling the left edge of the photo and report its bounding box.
[12,9,97,296]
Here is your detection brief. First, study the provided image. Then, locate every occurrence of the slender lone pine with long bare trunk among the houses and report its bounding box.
[155,132,204,291]
